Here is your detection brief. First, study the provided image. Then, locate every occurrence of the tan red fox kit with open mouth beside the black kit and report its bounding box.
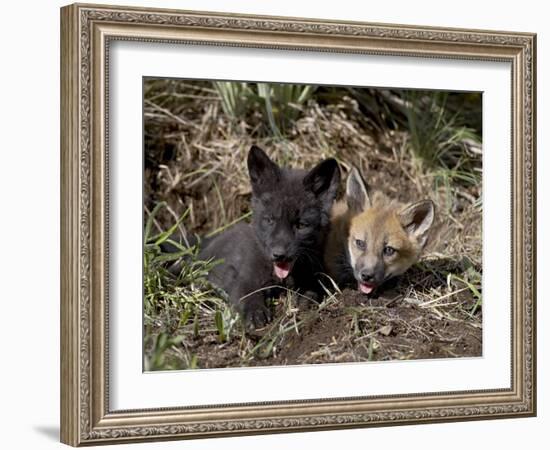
[324,168,434,294]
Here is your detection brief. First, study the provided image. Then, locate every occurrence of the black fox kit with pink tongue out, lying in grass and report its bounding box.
[199,146,340,326]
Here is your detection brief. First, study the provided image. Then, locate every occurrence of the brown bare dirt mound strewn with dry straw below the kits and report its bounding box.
[180,268,482,368]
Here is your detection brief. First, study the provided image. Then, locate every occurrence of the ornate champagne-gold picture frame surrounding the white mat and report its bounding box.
[61,4,536,446]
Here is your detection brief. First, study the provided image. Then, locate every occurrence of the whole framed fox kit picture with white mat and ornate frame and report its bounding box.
[61,4,536,446]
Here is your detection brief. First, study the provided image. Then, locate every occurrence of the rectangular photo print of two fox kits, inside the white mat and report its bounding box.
[143,77,483,371]
